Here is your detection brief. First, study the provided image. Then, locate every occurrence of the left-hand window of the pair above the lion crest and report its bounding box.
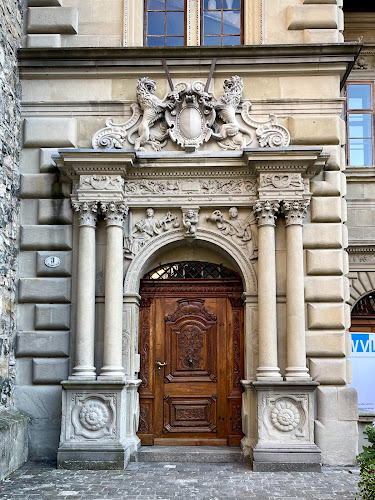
[145,0,186,47]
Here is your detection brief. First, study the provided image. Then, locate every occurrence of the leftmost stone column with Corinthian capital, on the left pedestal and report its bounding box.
[69,201,97,380]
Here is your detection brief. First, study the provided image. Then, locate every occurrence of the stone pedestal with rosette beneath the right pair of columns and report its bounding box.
[252,382,321,472]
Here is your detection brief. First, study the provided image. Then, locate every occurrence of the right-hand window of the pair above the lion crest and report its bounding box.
[202,0,242,45]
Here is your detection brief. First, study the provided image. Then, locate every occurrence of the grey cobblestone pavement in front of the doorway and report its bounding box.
[0,463,358,500]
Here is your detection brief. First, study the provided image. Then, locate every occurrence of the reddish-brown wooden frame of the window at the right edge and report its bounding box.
[345,80,375,168]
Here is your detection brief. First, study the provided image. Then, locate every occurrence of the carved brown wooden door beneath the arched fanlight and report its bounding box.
[138,280,244,446]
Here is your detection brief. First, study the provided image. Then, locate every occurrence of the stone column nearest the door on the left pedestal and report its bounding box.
[100,203,128,380]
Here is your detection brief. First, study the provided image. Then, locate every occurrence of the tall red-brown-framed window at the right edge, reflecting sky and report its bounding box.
[346,82,374,166]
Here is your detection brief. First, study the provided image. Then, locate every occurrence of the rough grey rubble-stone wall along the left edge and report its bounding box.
[0,0,22,411]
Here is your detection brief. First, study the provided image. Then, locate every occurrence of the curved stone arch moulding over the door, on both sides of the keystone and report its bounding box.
[124,229,257,295]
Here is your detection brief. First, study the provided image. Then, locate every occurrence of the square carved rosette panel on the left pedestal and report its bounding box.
[71,394,117,440]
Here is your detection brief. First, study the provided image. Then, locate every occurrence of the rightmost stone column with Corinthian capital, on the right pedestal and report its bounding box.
[283,200,311,381]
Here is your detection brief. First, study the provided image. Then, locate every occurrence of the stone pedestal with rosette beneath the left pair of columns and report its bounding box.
[57,381,133,469]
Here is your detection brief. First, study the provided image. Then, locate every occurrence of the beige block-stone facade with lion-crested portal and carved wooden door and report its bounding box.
[0,0,374,470]
